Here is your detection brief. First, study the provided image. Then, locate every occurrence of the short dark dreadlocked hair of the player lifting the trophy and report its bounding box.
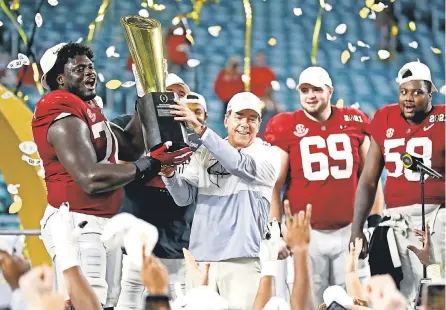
[46,42,94,90]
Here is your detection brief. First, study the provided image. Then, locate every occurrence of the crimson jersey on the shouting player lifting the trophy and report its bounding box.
[32,90,122,217]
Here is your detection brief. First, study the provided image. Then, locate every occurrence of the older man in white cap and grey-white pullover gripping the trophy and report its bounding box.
[162,92,281,309]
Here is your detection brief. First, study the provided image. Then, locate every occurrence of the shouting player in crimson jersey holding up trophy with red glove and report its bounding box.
[32,43,191,307]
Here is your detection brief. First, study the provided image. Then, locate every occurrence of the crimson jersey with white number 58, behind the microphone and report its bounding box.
[370,104,446,208]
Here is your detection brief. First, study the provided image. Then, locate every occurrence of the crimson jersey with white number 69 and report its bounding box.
[265,106,369,229]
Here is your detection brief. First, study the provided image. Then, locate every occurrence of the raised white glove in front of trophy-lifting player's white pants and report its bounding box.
[51,203,87,271]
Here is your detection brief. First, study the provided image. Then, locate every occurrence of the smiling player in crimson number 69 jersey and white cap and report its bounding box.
[265,67,382,304]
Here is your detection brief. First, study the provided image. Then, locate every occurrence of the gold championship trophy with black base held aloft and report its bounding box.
[121,16,187,152]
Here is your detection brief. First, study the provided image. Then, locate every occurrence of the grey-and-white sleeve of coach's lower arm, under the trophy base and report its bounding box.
[162,154,200,206]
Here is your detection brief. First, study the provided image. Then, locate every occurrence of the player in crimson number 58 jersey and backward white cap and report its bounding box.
[351,62,446,300]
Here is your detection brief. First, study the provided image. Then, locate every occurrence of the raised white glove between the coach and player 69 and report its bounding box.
[259,219,281,277]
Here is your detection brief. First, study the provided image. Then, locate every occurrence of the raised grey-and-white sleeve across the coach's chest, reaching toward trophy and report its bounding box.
[202,128,280,185]
